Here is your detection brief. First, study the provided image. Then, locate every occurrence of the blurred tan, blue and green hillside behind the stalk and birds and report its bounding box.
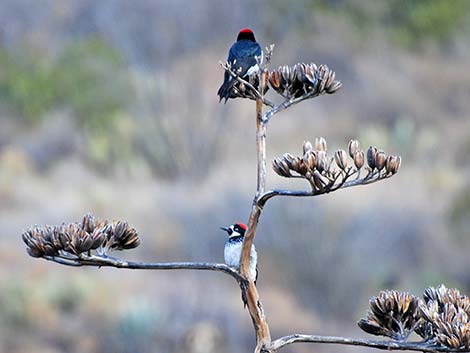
[0,0,470,353]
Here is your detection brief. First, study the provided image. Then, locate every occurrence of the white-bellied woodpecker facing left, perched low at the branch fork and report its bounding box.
[220,223,258,283]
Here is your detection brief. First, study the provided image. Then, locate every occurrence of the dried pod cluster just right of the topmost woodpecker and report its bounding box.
[269,63,342,98]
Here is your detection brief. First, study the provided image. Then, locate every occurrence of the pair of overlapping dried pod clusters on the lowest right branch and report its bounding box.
[358,285,470,350]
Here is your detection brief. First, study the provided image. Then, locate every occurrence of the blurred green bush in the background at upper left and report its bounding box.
[0,38,130,126]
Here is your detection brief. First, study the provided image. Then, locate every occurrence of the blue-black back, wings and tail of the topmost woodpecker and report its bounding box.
[217,40,262,102]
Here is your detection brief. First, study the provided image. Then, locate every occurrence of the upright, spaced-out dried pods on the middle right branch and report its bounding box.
[273,137,401,192]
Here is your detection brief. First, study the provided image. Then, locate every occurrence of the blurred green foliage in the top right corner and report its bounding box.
[311,0,470,49]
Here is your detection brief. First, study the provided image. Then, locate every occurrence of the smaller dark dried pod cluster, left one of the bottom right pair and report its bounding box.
[358,290,420,341]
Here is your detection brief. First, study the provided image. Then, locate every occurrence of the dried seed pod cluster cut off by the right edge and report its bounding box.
[416,284,470,349]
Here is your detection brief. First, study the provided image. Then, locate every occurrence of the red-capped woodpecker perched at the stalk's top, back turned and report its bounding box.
[217,28,263,103]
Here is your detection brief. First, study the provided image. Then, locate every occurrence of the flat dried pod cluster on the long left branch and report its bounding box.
[22,214,140,257]
